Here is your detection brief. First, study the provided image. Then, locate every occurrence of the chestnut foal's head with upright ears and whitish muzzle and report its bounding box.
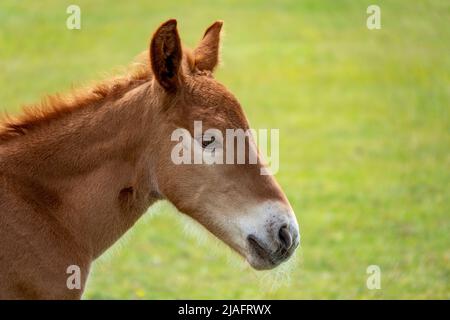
[150,20,300,269]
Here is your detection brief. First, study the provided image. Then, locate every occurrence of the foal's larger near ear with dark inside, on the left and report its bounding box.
[150,19,183,91]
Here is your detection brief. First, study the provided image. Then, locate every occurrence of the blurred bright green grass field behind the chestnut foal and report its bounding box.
[0,0,450,299]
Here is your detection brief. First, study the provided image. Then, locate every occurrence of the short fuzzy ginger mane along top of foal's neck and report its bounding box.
[0,52,152,142]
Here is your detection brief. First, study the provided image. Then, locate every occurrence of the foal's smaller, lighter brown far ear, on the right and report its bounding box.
[194,21,223,71]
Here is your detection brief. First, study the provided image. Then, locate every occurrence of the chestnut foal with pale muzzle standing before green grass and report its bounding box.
[0,20,300,299]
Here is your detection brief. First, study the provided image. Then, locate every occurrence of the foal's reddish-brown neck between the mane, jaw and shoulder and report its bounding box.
[0,83,163,258]
